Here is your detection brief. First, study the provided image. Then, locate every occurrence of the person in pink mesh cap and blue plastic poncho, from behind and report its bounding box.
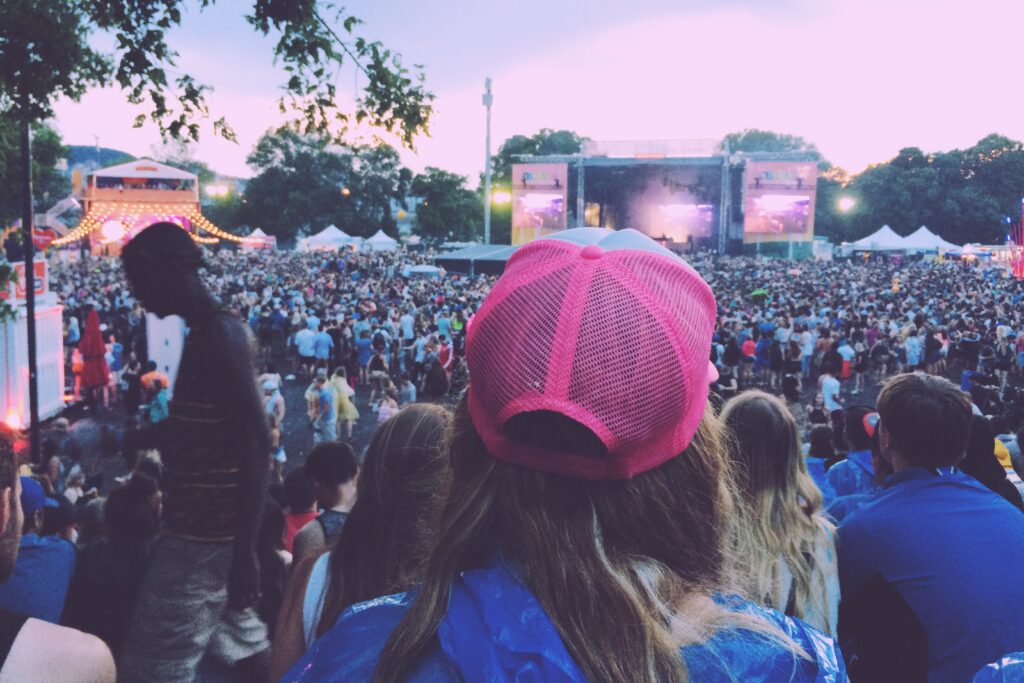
[282,228,846,683]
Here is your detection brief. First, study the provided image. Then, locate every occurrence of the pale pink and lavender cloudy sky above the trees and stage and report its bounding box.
[56,0,1024,183]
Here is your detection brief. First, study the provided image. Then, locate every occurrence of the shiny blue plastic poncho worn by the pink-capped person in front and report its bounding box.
[282,562,846,683]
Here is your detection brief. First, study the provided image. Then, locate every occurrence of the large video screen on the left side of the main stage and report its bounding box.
[512,164,568,245]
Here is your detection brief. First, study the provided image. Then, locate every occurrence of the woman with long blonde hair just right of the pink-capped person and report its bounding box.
[722,391,839,637]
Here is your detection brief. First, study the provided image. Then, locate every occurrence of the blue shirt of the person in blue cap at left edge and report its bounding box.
[0,533,75,624]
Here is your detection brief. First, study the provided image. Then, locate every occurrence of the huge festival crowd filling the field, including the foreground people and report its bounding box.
[0,225,1024,682]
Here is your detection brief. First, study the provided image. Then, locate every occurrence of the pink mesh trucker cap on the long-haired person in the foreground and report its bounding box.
[466,227,718,479]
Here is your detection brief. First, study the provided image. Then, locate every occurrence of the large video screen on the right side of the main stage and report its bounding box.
[743,162,818,243]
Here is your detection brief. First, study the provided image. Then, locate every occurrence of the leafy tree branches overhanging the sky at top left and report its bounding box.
[0,0,433,146]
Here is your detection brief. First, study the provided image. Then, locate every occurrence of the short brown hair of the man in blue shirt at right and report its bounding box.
[879,373,971,467]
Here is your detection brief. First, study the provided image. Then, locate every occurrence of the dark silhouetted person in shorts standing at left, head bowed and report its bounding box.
[120,223,269,682]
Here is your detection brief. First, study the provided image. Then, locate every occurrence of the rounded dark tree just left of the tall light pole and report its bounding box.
[412,167,483,242]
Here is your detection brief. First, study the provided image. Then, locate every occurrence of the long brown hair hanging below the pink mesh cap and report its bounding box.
[375,397,784,683]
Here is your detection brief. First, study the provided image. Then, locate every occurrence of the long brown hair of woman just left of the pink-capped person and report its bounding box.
[316,403,451,635]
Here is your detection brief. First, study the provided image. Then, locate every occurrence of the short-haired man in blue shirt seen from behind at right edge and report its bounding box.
[839,374,1024,681]
